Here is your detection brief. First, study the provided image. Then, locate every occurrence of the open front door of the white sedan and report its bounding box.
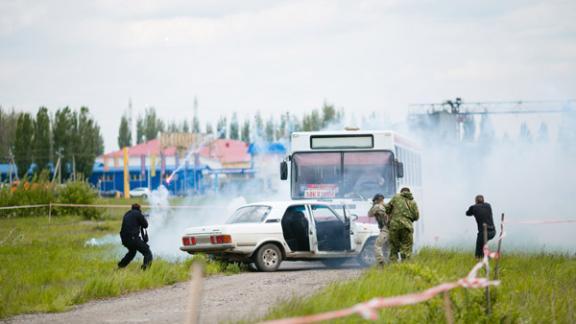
[310,204,350,252]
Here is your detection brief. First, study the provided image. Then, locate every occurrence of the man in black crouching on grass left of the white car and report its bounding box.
[118,204,152,270]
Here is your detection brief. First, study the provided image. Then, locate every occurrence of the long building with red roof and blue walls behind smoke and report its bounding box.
[89,136,253,195]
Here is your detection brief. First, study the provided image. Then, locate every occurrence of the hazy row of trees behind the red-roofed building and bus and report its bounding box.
[118,103,344,148]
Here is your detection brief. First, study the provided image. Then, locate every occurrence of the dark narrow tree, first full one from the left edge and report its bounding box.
[14,113,34,178]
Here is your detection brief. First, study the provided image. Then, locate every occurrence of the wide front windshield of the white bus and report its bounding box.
[292,151,396,199]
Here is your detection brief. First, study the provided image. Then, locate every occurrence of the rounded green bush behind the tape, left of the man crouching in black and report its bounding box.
[55,181,101,219]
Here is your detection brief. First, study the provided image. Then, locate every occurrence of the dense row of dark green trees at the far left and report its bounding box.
[0,107,104,180]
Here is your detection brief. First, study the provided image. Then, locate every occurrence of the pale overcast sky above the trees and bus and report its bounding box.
[0,0,576,151]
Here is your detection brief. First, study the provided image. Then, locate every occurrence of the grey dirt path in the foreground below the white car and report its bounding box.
[6,262,361,323]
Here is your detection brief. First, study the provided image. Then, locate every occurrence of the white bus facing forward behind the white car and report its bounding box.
[280,130,422,223]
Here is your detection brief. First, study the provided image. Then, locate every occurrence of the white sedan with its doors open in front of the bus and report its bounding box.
[180,201,379,271]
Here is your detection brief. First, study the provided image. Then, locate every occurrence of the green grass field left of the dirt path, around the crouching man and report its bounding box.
[0,216,244,319]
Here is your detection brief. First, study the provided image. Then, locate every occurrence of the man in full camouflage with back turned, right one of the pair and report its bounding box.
[386,192,419,261]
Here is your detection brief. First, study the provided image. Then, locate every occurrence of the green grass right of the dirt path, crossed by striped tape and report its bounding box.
[266,249,576,323]
